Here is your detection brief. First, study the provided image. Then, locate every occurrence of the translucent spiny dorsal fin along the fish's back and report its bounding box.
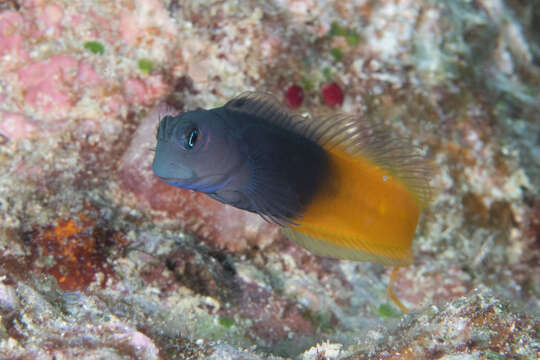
[221,92,431,206]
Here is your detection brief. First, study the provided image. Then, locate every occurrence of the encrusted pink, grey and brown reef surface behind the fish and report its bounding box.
[0,0,540,360]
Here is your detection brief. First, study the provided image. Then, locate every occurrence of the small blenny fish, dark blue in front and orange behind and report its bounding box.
[152,92,431,312]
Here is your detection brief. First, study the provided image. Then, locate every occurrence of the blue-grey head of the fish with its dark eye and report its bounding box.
[152,109,246,193]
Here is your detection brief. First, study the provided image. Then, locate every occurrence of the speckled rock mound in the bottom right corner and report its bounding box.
[355,289,540,360]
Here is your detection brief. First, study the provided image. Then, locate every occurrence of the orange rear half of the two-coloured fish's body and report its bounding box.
[292,150,422,265]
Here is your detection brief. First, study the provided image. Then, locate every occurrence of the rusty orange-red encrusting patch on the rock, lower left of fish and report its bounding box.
[33,214,125,291]
